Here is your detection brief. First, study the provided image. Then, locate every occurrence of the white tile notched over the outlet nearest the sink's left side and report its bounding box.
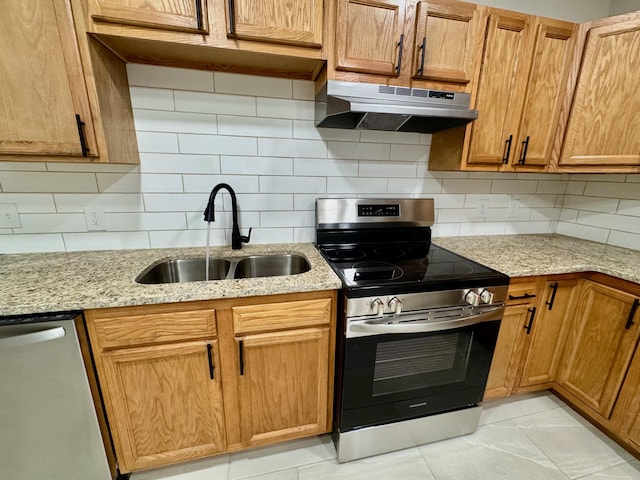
[53,193,144,212]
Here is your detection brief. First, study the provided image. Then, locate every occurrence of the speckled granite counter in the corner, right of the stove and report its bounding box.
[433,235,640,283]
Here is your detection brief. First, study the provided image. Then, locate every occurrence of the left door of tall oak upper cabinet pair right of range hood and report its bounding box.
[467,11,533,169]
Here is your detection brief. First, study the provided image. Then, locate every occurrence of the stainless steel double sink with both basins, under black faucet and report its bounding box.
[136,254,311,284]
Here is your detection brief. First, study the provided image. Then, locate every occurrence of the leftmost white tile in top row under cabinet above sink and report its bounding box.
[127,63,213,92]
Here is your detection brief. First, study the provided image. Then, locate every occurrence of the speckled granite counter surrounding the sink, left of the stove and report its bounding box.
[0,243,341,315]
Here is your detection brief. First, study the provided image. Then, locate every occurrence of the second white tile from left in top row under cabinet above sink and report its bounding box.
[218,72,293,98]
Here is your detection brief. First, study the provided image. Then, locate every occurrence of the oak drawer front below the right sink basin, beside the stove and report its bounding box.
[232,298,331,334]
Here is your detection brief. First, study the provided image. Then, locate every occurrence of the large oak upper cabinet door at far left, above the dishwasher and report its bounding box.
[0,0,97,160]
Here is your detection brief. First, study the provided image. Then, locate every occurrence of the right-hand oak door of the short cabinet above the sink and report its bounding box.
[227,0,323,47]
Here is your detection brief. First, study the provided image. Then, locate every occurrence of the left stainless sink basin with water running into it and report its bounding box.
[136,258,231,283]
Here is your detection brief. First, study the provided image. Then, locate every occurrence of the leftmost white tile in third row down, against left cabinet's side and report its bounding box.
[133,109,218,135]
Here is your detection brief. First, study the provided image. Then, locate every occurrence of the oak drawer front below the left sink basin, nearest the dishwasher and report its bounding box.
[86,306,216,348]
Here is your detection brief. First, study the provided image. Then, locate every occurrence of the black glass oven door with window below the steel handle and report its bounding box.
[338,316,502,432]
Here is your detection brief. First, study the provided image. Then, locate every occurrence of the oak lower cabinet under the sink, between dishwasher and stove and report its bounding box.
[85,291,337,473]
